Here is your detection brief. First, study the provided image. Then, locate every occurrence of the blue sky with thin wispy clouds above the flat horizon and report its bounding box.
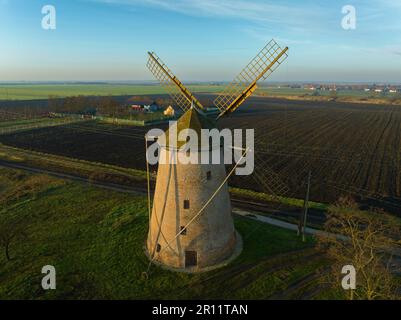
[0,0,401,82]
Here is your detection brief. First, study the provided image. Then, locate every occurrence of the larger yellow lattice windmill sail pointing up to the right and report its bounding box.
[214,40,288,118]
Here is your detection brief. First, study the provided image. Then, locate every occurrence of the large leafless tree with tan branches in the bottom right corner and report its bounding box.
[317,198,400,300]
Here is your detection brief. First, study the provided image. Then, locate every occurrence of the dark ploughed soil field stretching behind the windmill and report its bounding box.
[0,95,401,213]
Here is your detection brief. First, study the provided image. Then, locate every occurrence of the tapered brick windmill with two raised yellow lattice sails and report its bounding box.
[146,40,288,272]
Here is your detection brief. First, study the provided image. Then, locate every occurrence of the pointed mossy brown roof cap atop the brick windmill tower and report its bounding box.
[166,108,216,148]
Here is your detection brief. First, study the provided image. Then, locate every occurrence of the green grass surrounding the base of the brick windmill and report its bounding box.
[0,168,332,299]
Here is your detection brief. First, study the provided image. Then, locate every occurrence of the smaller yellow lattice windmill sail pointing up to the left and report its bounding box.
[147,52,204,112]
